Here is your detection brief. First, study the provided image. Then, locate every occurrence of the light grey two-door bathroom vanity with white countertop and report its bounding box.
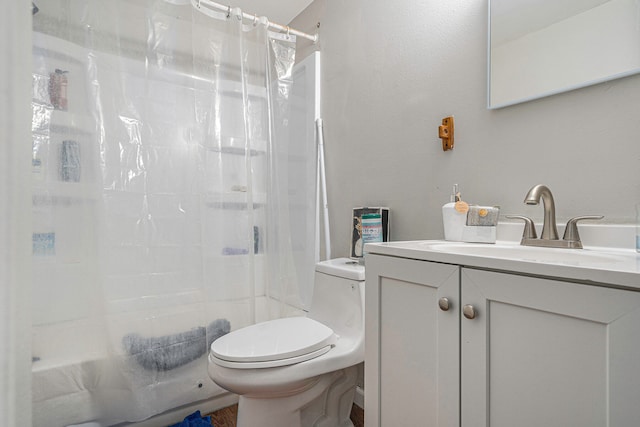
[365,236,640,427]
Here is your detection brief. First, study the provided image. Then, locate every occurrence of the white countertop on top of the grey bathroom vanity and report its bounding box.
[365,225,640,290]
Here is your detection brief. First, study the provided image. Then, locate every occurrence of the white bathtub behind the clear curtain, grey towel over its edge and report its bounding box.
[32,297,296,427]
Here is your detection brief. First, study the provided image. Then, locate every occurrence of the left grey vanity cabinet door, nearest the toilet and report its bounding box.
[365,255,460,427]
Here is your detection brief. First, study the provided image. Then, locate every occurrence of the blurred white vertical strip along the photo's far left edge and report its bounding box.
[0,2,31,427]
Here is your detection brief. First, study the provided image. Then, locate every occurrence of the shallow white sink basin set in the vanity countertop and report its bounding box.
[423,242,624,265]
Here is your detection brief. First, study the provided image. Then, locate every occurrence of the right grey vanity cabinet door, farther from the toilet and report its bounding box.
[461,268,640,427]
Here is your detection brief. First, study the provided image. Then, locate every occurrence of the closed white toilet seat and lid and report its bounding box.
[211,317,337,369]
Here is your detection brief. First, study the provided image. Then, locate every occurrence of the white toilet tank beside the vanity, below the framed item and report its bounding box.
[309,258,365,335]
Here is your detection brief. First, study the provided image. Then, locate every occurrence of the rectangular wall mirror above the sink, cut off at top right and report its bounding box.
[488,0,640,108]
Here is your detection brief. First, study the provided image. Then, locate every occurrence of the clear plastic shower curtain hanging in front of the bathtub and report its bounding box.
[32,0,316,426]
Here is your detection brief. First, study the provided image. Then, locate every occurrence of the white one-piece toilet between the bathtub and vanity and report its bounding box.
[208,258,364,427]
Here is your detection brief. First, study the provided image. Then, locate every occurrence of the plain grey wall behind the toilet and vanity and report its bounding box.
[291,0,640,256]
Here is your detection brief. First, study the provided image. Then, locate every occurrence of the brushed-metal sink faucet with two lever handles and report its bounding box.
[507,184,604,249]
